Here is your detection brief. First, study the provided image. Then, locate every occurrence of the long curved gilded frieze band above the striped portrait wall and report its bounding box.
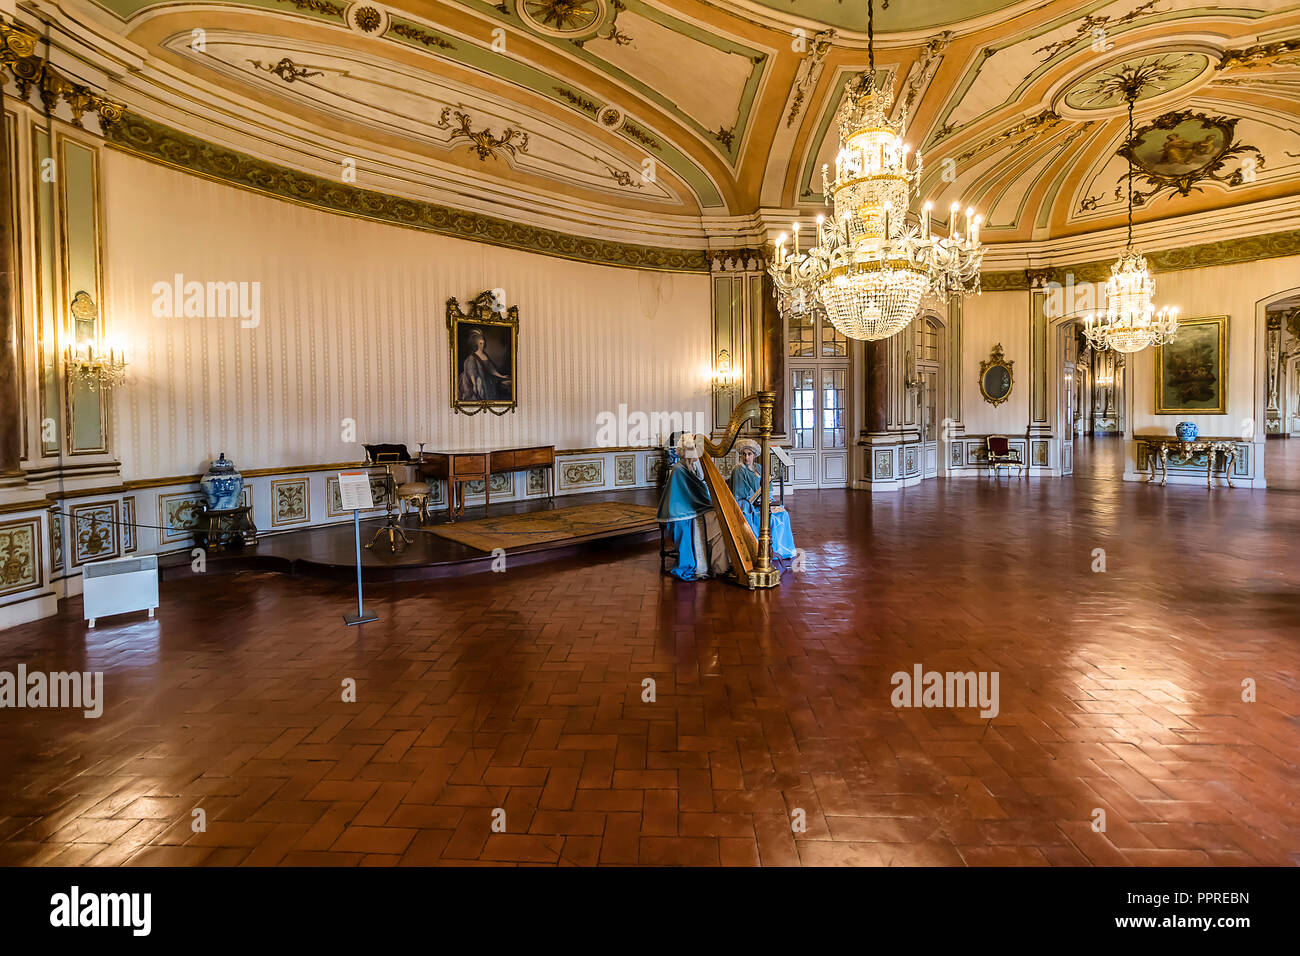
[107,112,709,272]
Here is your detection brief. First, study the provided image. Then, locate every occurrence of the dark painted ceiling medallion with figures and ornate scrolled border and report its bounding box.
[1115,111,1264,206]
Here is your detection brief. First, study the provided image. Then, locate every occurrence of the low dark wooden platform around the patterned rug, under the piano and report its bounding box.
[159,488,659,581]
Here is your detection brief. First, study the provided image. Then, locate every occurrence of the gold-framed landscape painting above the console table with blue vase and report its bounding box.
[1156,315,1227,415]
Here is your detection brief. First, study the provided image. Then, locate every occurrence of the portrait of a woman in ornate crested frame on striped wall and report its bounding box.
[447,289,519,415]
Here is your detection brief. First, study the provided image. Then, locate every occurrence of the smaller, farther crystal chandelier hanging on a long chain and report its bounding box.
[1083,85,1178,354]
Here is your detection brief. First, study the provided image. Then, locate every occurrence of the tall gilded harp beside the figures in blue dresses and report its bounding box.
[696,392,781,591]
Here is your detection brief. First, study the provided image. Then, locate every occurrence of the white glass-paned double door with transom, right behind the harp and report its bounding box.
[787,310,850,488]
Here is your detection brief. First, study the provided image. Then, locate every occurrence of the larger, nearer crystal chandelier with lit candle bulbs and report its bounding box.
[768,0,984,341]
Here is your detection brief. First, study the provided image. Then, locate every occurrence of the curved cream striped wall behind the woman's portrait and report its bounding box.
[103,150,711,480]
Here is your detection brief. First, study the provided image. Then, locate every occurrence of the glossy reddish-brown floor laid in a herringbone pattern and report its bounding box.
[0,442,1300,866]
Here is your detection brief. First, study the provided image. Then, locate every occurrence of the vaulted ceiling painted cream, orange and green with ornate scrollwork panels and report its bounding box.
[70,0,1300,242]
